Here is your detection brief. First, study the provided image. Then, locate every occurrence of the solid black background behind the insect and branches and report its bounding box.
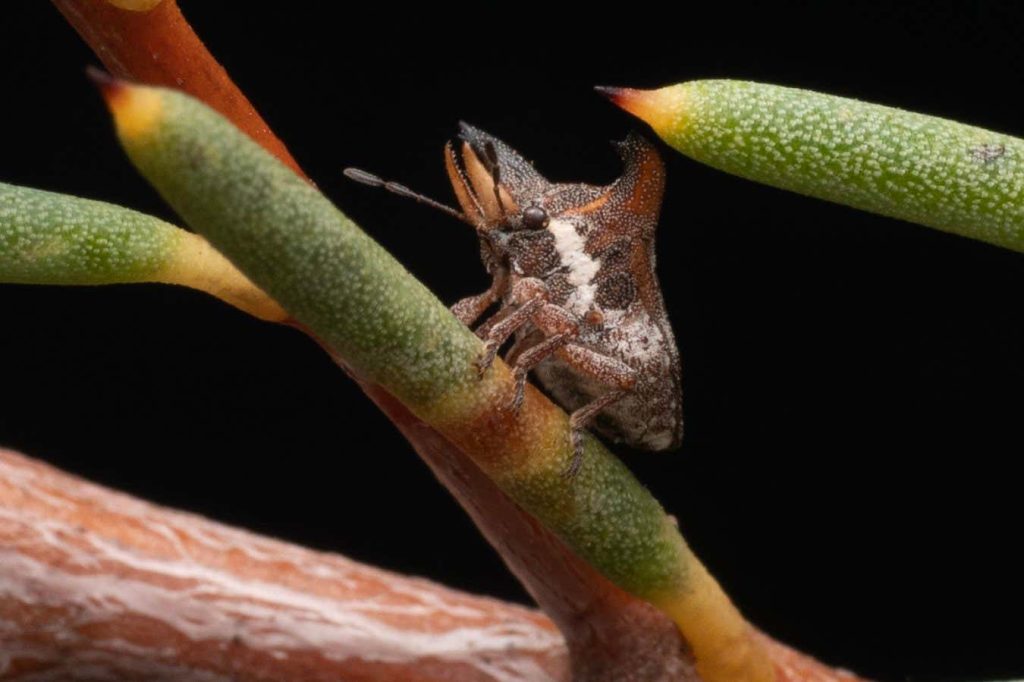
[0,0,1024,680]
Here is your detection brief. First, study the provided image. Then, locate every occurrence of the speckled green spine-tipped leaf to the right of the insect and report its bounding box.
[604,80,1024,251]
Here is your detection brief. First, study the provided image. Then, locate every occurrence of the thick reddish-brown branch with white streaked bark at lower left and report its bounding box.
[0,451,568,682]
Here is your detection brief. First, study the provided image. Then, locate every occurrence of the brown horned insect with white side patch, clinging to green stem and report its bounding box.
[345,124,683,476]
